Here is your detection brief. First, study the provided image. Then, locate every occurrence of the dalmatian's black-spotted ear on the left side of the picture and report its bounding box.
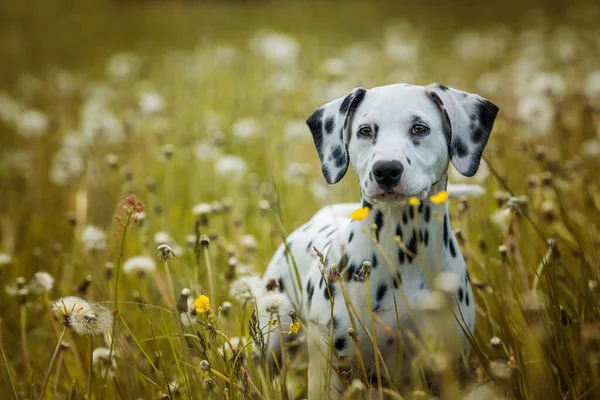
[306,88,367,184]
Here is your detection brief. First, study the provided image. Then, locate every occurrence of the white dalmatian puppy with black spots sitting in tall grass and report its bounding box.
[262,84,498,399]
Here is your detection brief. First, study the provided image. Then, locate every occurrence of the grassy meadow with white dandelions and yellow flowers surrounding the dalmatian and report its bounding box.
[0,0,600,400]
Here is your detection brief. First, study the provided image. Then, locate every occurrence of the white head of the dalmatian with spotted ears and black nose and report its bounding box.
[306,84,498,202]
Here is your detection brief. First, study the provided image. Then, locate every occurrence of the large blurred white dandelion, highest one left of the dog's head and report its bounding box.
[251,31,300,65]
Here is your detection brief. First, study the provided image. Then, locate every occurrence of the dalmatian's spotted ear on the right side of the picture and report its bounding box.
[425,83,499,176]
